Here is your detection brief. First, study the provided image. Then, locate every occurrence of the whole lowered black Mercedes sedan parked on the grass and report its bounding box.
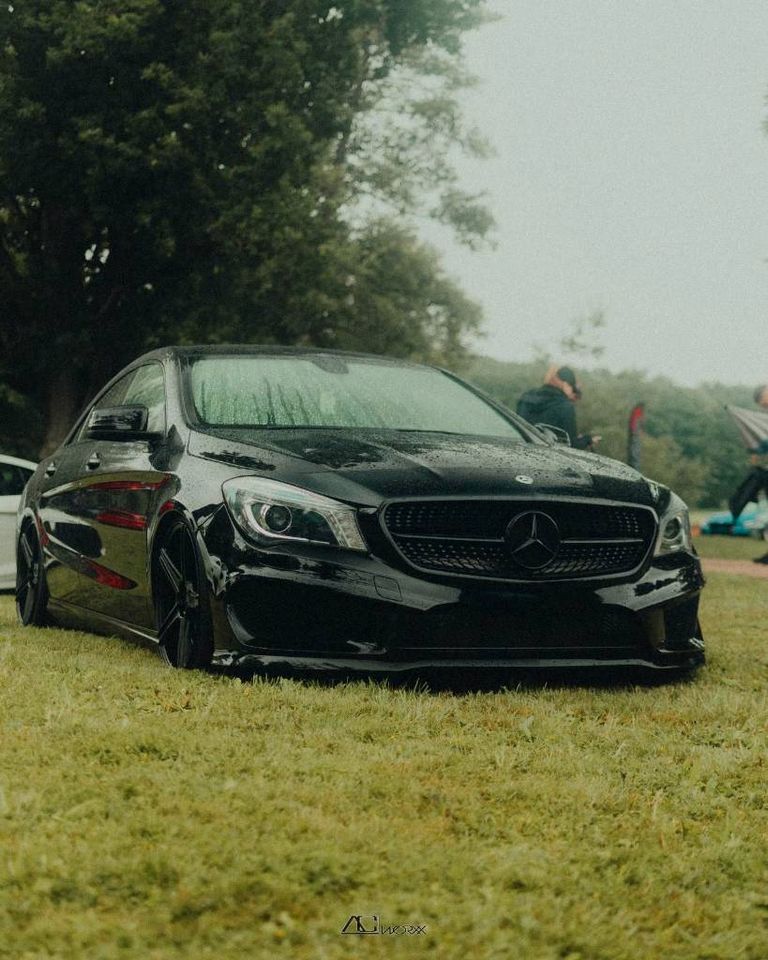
[16,346,704,674]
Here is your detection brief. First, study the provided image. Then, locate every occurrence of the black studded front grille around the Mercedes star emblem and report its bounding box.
[382,500,656,582]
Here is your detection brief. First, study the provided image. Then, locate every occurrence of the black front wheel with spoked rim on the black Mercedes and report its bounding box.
[152,516,213,670]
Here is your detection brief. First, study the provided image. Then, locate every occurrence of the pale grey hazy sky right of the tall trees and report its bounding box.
[430,0,768,384]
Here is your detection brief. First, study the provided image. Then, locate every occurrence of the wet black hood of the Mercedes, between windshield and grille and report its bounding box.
[189,428,654,506]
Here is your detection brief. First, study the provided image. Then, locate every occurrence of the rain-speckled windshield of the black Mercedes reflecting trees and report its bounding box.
[188,355,526,440]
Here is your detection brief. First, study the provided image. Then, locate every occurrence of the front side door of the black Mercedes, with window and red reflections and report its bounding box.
[65,362,168,627]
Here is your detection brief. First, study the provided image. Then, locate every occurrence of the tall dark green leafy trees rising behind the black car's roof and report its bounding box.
[0,0,489,450]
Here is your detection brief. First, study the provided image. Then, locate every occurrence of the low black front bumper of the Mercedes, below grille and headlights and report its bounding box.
[206,532,704,674]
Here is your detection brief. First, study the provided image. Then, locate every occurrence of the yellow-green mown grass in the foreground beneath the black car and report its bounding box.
[0,543,768,960]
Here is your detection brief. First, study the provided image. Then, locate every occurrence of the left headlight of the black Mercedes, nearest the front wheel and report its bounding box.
[221,477,368,553]
